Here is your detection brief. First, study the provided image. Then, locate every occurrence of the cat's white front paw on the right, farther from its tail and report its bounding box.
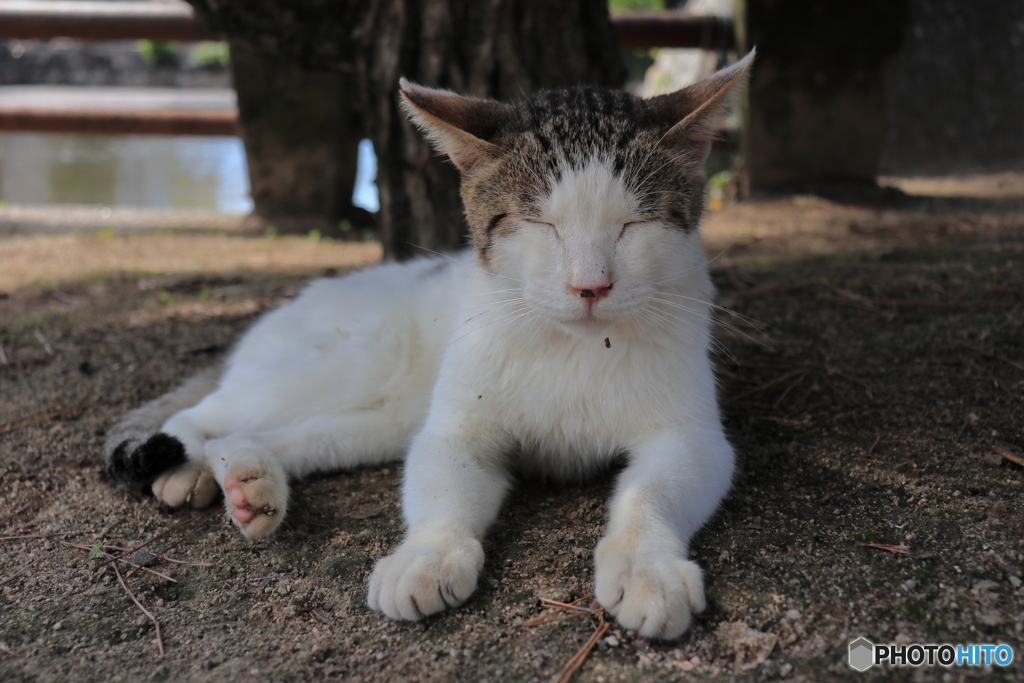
[594,538,706,640]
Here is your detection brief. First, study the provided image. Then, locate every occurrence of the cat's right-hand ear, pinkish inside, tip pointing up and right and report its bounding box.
[647,50,755,165]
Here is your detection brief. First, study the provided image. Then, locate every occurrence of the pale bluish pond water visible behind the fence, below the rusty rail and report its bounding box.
[0,133,378,214]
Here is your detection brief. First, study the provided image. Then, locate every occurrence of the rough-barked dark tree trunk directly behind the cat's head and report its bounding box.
[189,0,625,259]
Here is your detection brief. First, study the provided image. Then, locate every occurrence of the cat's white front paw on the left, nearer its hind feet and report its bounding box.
[367,531,483,622]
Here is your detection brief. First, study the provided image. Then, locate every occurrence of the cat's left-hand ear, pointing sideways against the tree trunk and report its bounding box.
[399,79,508,173]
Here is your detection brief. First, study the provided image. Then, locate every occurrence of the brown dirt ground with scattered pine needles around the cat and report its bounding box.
[0,181,1024,683]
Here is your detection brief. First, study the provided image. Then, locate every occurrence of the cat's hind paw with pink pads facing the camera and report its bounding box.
[224,467,288,539]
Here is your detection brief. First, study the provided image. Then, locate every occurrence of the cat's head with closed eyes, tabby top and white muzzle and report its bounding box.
[401,52,754,333]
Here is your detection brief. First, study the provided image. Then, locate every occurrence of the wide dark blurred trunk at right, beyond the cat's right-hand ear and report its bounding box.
[734,0,909,195]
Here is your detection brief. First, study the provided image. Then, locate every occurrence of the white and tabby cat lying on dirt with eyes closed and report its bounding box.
[104,49,753,639]
